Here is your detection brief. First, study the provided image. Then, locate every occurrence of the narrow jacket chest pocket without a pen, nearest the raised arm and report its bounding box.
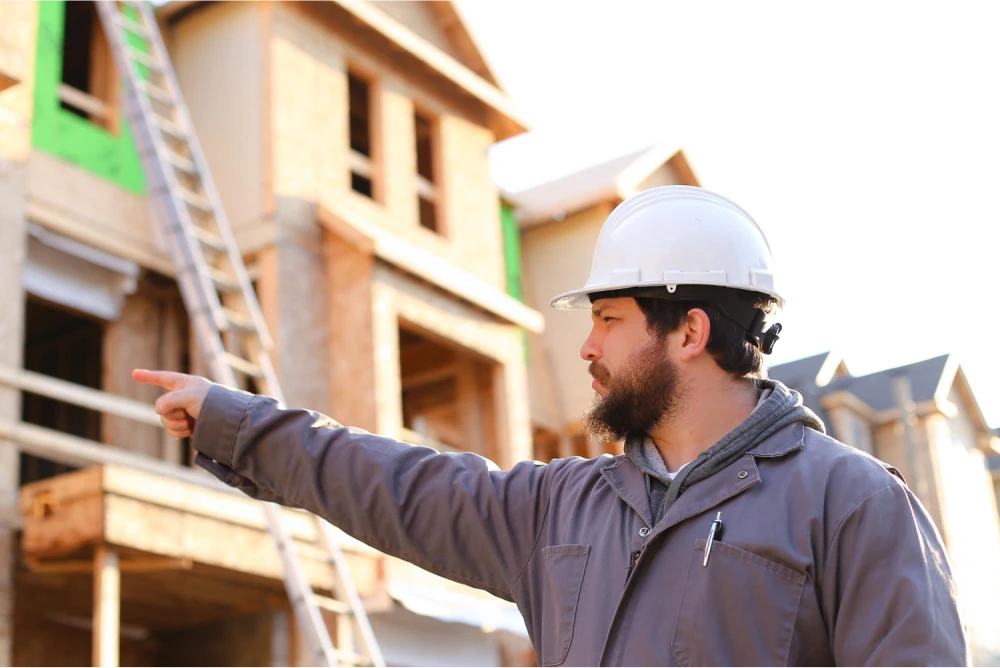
[539,545,590,666]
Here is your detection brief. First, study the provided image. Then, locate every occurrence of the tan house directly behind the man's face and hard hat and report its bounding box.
[501,144,698,460]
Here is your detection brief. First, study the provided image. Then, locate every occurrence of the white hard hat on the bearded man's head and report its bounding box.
[552,186,784,309]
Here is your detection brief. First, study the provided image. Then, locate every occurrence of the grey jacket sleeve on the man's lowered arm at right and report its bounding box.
[823,481,971,668]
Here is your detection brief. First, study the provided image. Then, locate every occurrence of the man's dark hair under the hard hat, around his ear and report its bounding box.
[591,286,777,378]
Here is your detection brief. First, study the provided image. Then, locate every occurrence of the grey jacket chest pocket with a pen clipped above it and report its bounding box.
[670,539,806,668]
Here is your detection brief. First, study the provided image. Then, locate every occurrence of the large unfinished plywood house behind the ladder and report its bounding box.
[0,0,542,667]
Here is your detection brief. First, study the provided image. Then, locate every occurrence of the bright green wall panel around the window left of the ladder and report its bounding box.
[31,0,148,195]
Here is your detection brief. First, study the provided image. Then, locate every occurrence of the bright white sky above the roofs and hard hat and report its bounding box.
[468,0,1000,426]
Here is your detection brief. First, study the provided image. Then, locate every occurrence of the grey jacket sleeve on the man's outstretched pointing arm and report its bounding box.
[192,386,554,600]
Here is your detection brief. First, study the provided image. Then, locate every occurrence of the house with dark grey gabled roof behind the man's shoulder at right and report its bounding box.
[769,353,1000,666]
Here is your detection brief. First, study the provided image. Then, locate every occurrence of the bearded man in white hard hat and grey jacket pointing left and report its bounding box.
[135,186,969,668]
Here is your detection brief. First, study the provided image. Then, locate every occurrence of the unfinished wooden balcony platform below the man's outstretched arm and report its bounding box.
[15,465,377,592]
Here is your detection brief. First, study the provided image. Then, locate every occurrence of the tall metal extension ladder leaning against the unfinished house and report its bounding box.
[94,0,385,668]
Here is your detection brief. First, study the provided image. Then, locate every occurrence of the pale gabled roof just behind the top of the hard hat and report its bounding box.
[504,143,698,224]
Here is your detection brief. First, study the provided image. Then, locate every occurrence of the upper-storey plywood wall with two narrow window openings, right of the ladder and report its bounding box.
[271,3,505,290]
